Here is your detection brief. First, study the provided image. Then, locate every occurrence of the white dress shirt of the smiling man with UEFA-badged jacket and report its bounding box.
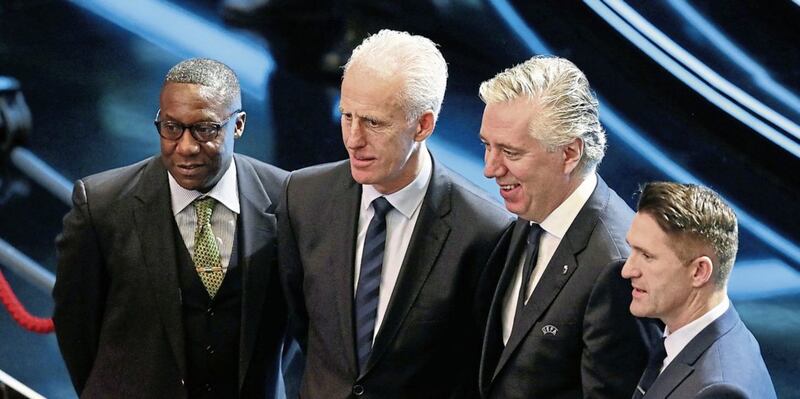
[502,173,597,345]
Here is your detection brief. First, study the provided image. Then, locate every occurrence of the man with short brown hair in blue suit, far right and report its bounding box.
[622,182,775,399]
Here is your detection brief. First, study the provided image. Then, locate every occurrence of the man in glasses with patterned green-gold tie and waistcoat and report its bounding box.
[53,59,287,398]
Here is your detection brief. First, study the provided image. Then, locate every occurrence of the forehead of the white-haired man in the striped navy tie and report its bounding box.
[340,65,403,113]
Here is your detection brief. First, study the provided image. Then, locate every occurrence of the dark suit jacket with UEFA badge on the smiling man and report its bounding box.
[480,177,647,399]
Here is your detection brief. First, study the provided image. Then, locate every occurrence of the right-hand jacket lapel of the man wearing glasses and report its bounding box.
[236,157,276,388]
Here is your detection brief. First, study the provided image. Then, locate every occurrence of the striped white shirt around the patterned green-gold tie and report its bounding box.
[167,159,239,273]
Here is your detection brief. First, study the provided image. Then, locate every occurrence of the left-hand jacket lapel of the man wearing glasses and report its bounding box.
[133,157,186,377]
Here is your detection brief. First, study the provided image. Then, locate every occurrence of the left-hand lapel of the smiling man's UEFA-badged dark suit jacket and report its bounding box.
[480,219,529,390]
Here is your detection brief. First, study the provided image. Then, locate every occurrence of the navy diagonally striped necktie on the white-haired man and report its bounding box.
[355,197,392,373]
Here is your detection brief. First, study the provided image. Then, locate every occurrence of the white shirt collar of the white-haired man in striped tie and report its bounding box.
[361,142,433,219]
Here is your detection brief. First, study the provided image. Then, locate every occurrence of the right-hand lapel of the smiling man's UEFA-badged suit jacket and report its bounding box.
[494,178,610,377]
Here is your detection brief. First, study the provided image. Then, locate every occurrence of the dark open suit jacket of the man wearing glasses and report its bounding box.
[53,155,287,398]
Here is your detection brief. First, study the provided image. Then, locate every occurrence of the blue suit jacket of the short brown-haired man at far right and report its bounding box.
[644,305,776,399]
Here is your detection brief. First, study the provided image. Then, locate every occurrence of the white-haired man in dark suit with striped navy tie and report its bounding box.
[278,30,510,398]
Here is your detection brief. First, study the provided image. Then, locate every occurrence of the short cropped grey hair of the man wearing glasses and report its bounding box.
[164,58,242,108]
